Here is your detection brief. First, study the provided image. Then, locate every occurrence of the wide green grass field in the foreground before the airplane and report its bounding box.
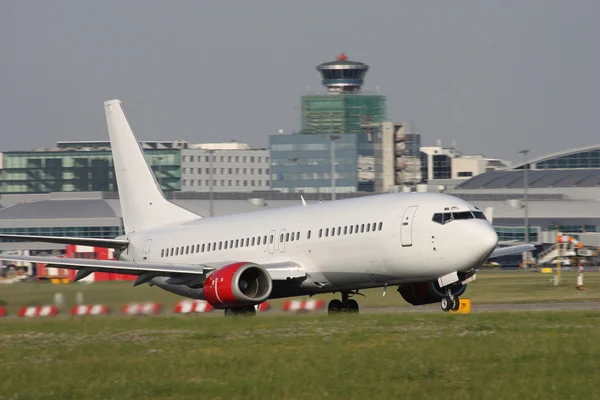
[0,312,600,400]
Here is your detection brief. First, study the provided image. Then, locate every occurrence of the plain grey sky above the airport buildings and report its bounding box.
[0,0,600,160]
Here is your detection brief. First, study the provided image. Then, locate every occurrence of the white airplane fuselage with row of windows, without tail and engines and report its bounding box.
[121,193,497,297]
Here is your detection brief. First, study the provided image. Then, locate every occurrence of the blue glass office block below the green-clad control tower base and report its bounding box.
[269,133,378,193]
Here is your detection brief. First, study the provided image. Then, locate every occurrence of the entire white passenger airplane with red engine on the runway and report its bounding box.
[0,100,533,315]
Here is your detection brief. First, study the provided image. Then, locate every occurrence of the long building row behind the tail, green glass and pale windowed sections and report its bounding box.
[0,140,270,194]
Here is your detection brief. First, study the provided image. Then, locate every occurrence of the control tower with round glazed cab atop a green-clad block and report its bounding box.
[301,53,386,134]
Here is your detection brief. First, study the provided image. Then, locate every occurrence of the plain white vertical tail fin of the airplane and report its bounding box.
[104,100,200,233]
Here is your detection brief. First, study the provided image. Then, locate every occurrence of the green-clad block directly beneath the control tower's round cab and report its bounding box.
[301,93,386,134]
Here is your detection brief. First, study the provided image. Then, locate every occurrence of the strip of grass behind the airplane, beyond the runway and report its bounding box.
[0,271,600,315]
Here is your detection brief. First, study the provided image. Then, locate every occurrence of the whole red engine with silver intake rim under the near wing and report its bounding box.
[203,262,273,309]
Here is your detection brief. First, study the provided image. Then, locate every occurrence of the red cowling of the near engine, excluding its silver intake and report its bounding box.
[203,261,248,309]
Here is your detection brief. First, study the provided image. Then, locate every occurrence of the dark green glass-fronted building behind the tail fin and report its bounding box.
[0,149,181,194]
